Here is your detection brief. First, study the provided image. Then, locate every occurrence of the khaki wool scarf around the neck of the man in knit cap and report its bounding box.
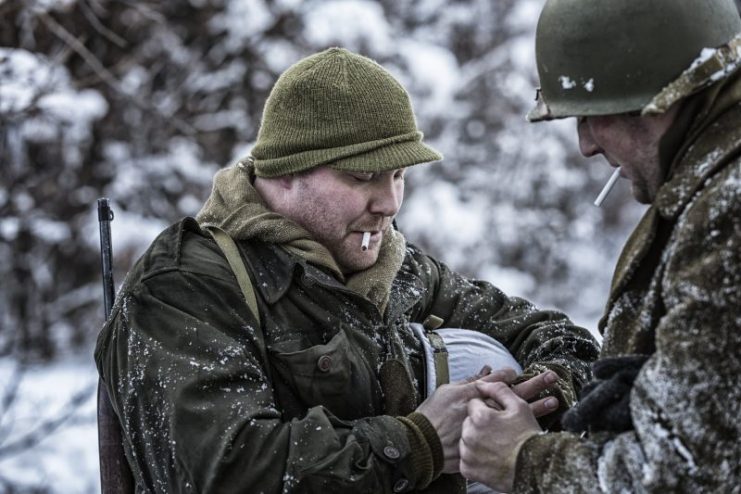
[196,163,406,314]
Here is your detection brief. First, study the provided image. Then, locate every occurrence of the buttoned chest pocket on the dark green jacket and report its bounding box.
[271,330,378,420]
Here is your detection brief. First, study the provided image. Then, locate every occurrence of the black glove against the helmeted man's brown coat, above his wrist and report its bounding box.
[561,355,650,432]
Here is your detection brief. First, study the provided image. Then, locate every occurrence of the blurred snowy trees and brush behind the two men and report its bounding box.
[0,0,740,493]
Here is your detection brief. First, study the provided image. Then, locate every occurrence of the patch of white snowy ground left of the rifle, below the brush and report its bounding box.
[0,352,100,494]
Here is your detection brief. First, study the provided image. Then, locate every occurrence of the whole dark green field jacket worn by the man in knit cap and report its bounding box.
[95,219,596,494]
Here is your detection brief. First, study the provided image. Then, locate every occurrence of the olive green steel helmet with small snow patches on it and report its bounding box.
[528,0,741,121]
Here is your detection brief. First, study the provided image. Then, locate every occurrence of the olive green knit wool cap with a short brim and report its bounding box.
[246,48,442,177]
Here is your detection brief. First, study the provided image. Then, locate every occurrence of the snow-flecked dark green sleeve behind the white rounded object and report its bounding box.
[408,247,599,420]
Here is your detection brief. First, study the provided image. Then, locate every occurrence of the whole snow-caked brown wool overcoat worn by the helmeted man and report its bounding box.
[515,98,741,493]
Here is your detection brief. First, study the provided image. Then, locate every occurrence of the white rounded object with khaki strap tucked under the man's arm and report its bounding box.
[410,323,522,398]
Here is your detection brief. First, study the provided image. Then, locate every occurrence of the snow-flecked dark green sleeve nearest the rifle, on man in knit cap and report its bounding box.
[96,270,432,493]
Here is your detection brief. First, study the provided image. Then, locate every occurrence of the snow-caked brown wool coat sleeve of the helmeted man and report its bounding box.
[508,166,741,493]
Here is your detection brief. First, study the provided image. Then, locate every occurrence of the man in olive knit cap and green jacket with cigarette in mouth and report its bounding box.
[96,48,596,494]
